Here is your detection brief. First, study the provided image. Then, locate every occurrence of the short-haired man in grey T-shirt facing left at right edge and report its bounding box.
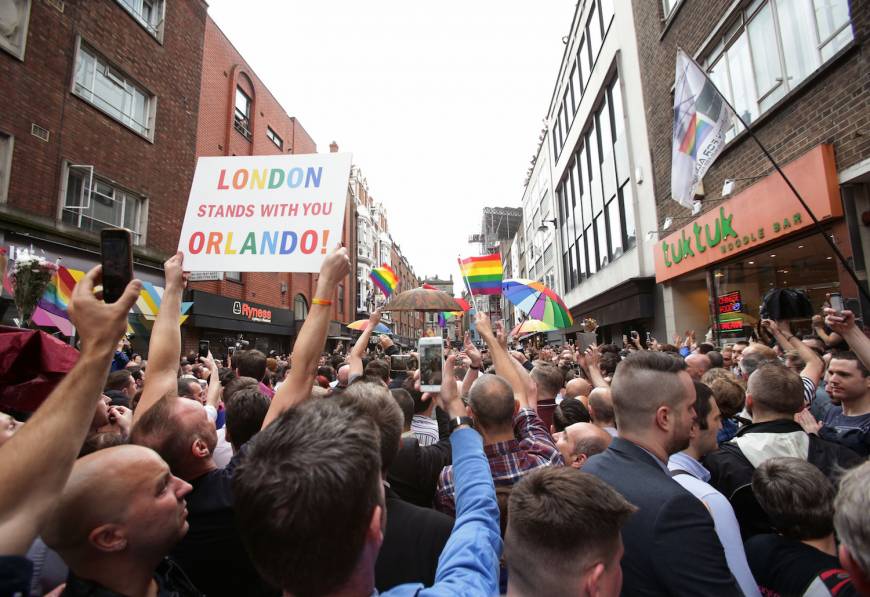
[819,351,870,456]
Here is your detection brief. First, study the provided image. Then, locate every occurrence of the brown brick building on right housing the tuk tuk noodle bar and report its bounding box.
[632,0,870,340]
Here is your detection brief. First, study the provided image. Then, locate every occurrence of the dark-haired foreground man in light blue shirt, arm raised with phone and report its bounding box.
[233,340,504,596]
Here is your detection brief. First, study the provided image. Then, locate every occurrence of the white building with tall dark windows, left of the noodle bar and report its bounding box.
[540,0,656,342]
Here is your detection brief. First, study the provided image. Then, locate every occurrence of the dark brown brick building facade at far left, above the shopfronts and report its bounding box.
[0,0,206,344]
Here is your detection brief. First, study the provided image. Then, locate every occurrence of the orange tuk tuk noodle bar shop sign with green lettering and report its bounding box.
[655,145,843,283]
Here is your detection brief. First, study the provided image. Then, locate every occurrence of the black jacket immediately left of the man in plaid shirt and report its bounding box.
[387,436,451,508]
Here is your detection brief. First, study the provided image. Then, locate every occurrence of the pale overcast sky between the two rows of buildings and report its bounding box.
[209,0,575,288]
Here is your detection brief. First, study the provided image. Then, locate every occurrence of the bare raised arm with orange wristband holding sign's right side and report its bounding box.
[262,247,350,429]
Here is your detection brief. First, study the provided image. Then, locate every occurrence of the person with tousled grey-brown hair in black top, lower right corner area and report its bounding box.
[746,458,867,595]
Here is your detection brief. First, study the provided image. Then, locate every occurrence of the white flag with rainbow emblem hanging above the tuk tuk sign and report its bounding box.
[671,49,734,208]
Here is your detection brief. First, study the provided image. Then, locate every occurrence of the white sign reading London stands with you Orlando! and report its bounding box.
[178,153,351,272]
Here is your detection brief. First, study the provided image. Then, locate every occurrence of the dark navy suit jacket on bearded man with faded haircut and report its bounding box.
[583,437,740,597]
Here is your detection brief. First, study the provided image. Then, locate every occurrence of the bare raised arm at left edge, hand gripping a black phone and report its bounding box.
[0,266,142,556]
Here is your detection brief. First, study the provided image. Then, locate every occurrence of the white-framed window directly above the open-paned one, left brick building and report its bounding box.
[73,43,155,139]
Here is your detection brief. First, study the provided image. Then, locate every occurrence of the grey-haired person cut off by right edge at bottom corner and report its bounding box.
[834,462,870,595]
